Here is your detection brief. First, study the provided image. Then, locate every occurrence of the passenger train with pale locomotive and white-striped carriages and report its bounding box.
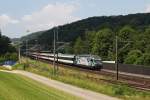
[29,52,103,69]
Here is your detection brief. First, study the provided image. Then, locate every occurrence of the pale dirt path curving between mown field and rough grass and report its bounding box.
[0,70,118,100]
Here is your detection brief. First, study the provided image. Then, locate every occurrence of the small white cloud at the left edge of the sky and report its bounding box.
[0,14,19,27]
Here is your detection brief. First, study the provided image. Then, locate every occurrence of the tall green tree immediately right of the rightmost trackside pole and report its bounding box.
[118,25,136,63]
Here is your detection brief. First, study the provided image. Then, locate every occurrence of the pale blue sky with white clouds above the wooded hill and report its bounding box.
[0,0,150,38]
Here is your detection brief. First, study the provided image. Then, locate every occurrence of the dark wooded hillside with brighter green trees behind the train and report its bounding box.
[22,13,150,65]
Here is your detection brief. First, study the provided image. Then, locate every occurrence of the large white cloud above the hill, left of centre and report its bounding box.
[21,3,79,32]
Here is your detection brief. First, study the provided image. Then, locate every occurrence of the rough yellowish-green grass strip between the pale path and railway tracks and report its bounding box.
[14,58,150,100]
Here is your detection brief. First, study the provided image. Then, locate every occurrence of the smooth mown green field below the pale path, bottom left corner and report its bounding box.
[0,71,79,100]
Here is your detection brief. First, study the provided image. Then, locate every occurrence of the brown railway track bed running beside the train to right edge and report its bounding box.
[29,56,150,91]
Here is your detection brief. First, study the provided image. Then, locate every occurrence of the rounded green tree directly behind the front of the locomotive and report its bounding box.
[92,29,115,59]
